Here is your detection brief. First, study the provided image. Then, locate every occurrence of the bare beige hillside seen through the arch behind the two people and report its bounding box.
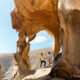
[29,47,52,69]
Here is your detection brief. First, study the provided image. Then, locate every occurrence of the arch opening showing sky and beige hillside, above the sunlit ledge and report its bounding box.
[29,30,55,69]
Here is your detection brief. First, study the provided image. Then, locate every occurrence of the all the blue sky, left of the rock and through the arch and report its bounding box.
[0,0,53,53]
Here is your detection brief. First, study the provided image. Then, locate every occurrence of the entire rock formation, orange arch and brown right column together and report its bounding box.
[11,0,80,80]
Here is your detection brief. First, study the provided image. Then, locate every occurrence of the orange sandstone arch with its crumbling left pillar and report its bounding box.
[11,0,60,77]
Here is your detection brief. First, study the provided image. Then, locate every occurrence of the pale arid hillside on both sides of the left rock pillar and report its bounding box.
[0,47,52,80]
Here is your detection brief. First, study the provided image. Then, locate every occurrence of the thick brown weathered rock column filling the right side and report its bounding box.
[54,0,80,78]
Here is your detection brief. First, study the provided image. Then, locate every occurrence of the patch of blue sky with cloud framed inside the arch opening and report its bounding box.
[31,31,53,50]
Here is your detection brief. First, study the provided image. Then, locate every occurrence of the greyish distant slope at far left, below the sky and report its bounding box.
[0,54,14,77]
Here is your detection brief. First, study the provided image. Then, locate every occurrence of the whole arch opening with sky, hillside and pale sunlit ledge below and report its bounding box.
[22,30,55,79]
